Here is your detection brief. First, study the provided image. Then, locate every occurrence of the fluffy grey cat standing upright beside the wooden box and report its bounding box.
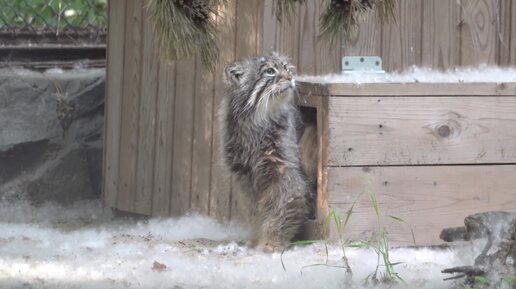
[219,54,310,250]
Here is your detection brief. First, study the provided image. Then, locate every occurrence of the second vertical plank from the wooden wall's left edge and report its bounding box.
[116,0,143,212]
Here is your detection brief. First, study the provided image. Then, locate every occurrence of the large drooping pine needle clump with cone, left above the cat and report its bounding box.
[147,0,225,69]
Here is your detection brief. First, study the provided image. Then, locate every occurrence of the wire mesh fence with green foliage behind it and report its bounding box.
[0,0,107,42]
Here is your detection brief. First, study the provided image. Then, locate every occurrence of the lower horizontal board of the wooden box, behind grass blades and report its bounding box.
[328,165,516,245]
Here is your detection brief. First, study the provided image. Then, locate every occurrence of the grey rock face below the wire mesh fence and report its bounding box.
[0,69,105,203]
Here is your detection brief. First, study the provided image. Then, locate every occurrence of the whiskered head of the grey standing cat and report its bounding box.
[224,53,295,113]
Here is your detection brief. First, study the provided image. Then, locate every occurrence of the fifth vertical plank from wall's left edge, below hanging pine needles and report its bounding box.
[170,59,196,215]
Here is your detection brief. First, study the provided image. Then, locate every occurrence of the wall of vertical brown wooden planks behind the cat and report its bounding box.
[104,0,516,220]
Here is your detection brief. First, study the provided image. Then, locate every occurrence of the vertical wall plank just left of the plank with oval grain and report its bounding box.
[421,0,460,70]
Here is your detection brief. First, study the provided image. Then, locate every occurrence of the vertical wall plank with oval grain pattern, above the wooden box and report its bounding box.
[460,0,499,66]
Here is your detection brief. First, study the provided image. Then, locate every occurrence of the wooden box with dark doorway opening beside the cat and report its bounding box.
[300,82,516,245]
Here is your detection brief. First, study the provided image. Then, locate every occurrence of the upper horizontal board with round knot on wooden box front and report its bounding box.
[328,97,516,166]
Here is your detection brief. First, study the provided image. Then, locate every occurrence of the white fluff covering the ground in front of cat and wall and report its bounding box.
[0,201,472,289]
